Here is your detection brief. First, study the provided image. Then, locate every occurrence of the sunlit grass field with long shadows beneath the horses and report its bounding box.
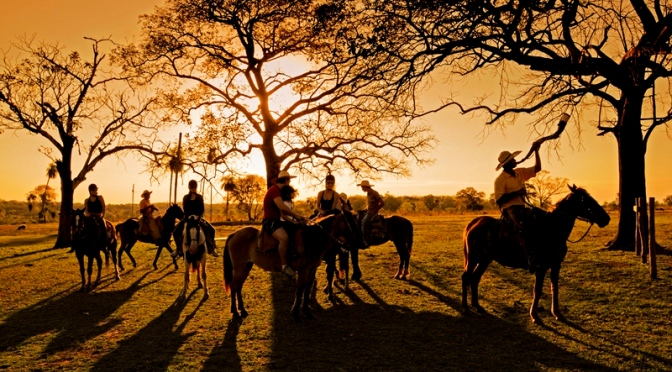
[0,212,672,371]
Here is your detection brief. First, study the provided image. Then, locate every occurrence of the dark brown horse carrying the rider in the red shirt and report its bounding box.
[223,214,354,322]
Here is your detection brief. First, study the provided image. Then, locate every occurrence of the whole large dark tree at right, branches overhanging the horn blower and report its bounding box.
[372,0,672,249]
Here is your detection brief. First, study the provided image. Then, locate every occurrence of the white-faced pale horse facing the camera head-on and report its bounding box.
[178,216,210,300]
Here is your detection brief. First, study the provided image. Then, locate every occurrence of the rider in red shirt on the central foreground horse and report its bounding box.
[261,171,306,277]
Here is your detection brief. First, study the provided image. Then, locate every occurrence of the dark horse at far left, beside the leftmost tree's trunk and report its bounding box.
[71,209,119,292]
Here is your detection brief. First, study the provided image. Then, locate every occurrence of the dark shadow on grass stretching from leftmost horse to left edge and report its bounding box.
[0,273,168,354]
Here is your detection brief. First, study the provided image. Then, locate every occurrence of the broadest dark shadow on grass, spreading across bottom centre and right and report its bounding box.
[263,274,612,371]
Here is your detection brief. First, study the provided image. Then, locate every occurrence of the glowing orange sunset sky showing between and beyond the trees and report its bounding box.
[0,0,672,203]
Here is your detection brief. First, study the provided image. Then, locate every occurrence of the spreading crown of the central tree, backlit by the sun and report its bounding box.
[120,0,435,186]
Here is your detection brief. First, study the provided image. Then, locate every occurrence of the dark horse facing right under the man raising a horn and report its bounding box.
[462,186,610,323]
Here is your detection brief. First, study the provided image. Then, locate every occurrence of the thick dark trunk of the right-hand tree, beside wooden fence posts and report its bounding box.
[607,95,646,251]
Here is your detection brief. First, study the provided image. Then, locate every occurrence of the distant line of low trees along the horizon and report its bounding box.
[0,194,497,225]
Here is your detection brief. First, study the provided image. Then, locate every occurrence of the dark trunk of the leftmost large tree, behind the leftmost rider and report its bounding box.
[54,144,75,248]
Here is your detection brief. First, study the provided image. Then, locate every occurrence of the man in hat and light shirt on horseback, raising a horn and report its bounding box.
[495,142,541,270]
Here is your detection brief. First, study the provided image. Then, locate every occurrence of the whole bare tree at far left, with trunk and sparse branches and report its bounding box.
[0,39,167,247]
